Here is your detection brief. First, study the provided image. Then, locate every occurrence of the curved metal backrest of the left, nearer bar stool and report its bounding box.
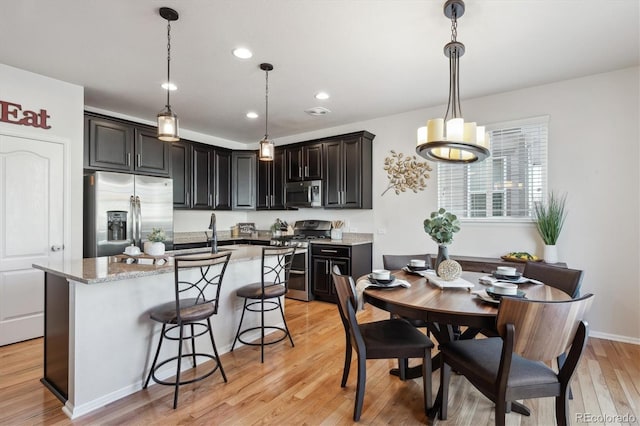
[174,252,231,322]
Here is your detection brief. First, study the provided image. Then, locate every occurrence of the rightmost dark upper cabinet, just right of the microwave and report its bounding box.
[322,131,375,209]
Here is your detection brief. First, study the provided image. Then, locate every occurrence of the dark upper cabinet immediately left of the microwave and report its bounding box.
[256,148,286,210]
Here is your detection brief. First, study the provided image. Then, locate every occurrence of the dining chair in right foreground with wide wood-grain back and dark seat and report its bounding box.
[439,294,593,425]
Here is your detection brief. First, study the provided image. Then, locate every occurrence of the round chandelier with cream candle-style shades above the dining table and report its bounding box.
[416,0,490,163]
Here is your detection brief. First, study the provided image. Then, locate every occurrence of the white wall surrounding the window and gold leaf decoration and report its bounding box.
[260,68,640,343]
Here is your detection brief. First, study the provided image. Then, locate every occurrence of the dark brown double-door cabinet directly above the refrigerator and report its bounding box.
[84,114,171,176]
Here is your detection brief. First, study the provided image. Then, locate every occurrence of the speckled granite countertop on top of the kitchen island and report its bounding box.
[33,245,290,284]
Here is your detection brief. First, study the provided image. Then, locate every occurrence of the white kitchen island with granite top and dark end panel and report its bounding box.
[33,245,294,418]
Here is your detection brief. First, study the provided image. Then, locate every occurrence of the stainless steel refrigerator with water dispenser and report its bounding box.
[84,172,173,257]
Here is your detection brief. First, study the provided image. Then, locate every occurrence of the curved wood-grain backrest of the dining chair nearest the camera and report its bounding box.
[497,294,593,361]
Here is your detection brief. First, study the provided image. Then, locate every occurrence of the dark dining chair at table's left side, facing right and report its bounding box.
[331,271,434,421]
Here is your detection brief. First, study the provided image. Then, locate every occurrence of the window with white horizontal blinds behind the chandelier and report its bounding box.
[438,117,549,221]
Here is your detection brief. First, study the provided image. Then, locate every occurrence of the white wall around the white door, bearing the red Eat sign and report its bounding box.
[0,64,84,259]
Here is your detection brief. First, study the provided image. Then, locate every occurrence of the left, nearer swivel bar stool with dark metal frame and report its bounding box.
[142,252,231,409]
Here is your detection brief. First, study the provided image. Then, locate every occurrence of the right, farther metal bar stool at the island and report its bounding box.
[231,247,296,363]
